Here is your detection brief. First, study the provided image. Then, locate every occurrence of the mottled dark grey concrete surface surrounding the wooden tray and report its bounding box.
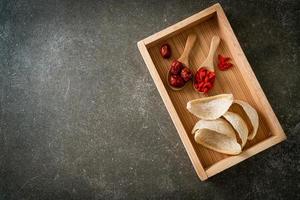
[0,0,300,200]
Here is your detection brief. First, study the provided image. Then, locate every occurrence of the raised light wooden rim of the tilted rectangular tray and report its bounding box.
[137,3,286,181]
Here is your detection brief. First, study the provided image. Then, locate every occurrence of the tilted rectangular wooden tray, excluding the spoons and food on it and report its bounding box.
[138,4,286,180]
